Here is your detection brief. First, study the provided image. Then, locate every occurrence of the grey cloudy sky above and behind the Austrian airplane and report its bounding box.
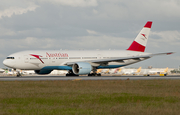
[0,0,180,68]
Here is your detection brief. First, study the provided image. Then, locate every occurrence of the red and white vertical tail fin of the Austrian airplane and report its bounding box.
[127,21,152,52]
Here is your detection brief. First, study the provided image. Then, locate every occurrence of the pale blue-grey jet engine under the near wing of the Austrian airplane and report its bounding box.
[72,62,92,75]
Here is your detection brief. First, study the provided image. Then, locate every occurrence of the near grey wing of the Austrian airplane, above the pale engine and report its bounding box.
[65,52,174,66]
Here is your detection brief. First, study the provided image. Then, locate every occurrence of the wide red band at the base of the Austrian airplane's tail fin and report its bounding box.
[127,41,146,52]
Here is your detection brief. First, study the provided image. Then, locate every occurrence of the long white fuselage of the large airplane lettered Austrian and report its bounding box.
[3,50,150,70]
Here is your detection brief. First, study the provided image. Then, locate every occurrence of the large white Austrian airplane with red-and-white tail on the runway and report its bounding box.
[3,21,174,77]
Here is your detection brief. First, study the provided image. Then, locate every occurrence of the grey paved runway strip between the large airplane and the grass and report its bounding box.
[0,76,180,81]
